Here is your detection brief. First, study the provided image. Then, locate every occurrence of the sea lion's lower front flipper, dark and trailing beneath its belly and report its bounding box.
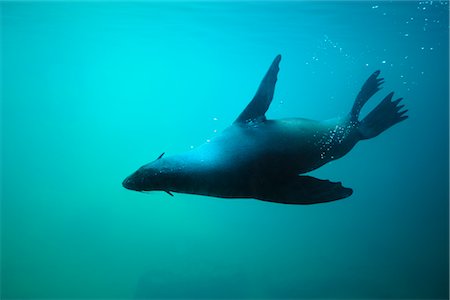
[255,176,353,204]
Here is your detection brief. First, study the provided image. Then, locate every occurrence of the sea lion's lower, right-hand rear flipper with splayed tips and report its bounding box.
[358,92,408,139]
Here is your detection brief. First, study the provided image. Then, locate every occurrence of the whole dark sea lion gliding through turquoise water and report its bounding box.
[123,55,408,204]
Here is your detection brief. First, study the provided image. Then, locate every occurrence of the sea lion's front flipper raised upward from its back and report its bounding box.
[234,55,281,123]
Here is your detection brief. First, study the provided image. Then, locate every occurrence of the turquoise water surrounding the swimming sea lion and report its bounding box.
[0,1,449,299]
